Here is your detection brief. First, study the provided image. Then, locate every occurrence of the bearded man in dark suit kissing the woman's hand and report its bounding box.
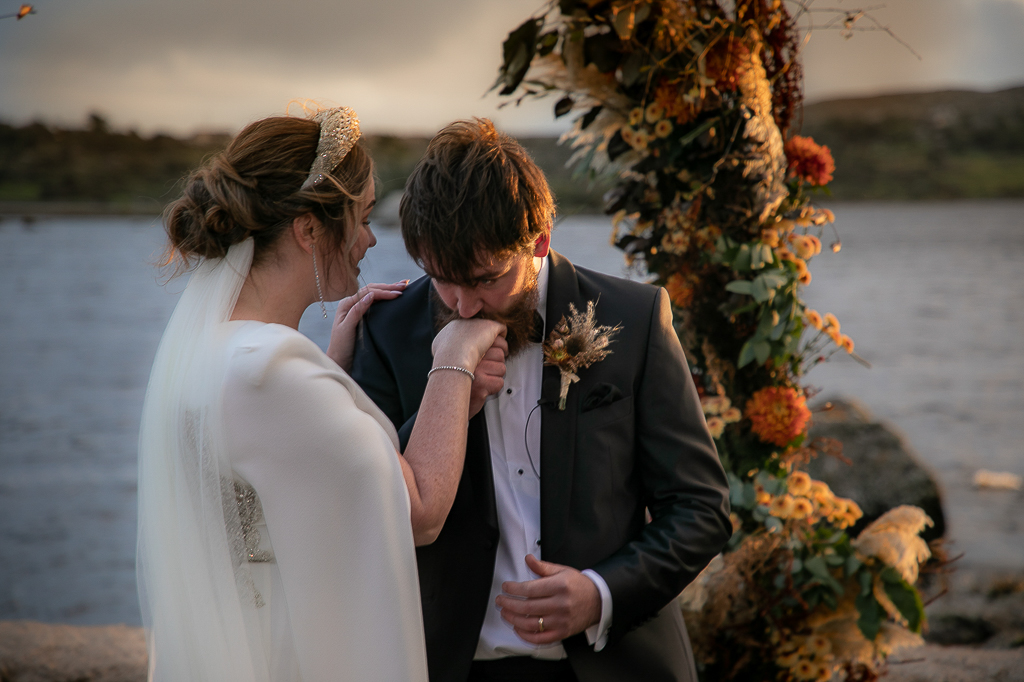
[352,120,731,682]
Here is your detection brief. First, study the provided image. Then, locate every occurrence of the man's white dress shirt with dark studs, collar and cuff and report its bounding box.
[474,253,611,660]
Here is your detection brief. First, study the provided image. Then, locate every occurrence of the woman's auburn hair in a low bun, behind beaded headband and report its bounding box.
[164,117,373,269]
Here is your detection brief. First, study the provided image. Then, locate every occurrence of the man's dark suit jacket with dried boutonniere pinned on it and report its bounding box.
[352,252,732,682]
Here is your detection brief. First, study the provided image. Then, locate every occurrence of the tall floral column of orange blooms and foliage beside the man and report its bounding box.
[500,0,937,682]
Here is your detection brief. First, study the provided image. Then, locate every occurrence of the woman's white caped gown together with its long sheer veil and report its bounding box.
[137,240,427,682]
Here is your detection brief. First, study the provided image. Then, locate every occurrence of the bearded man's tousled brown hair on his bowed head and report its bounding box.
[398,119,555,284]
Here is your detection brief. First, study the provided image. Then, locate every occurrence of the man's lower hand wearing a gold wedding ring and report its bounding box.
[496,554,601,644]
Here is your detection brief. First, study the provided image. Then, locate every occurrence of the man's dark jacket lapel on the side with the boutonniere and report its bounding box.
[541,251,584,561]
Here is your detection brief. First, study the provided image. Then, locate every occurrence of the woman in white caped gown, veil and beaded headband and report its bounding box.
[137,109,506,682]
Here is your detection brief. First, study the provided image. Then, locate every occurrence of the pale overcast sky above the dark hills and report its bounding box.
[0,0,1024,134]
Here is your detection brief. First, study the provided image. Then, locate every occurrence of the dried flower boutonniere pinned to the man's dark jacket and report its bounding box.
[544,301,621,410]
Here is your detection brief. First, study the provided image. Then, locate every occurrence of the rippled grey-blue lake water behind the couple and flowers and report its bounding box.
[0,202,1024,625]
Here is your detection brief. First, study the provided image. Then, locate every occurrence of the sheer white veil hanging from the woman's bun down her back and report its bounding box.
[136,239,269,682]
